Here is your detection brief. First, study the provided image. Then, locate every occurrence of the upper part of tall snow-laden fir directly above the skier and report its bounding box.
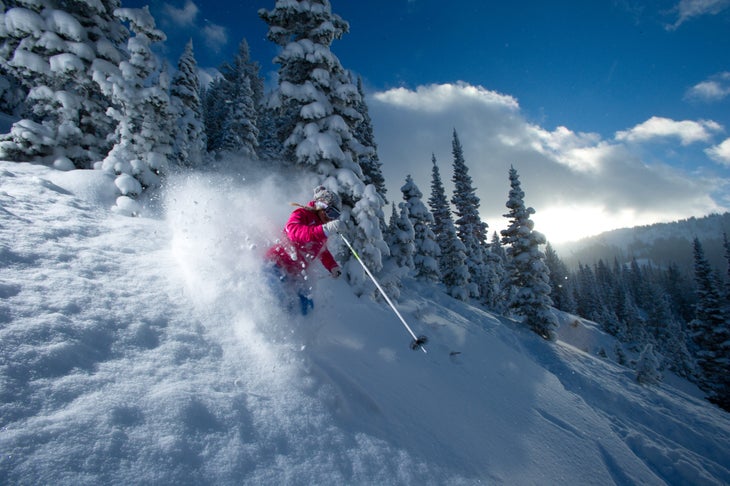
[259,0,363,174]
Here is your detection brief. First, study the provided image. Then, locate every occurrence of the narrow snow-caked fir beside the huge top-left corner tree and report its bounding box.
[99,7,173,214]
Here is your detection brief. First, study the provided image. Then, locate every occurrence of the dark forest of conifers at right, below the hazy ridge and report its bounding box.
[546,235,730,410]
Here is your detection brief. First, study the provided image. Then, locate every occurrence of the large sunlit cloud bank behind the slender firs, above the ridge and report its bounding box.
[368,83,727,245]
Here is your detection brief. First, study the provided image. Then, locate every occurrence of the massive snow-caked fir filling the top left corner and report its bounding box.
[0,0,125,168]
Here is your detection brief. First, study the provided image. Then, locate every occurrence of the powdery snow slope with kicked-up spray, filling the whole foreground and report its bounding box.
[0,162,730,485]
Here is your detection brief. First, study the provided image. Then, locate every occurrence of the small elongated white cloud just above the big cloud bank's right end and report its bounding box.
[616,116,722,145]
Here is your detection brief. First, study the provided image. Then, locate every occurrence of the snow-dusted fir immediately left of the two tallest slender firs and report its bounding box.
[400,174,441,282]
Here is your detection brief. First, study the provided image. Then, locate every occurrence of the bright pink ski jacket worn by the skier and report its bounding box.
[266,202,337,275]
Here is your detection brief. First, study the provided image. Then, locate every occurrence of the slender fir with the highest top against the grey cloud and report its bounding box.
[451,130,489,299]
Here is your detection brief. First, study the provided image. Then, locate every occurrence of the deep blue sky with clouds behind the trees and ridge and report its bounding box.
[134,0,730,242]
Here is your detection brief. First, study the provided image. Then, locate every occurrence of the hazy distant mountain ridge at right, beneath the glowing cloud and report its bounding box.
[553,213,730,274]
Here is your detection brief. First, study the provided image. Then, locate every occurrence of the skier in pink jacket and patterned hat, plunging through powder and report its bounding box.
[266,186,345,315]
